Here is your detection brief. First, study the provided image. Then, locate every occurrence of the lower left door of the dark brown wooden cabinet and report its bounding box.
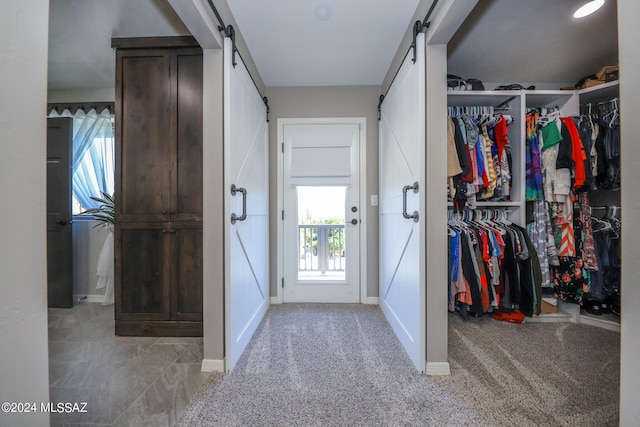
[116,223,171,320]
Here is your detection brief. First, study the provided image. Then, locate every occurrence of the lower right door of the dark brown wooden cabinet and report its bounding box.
[171,227,202,321]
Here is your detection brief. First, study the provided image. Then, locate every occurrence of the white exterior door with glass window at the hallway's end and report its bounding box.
[283,123,360,303]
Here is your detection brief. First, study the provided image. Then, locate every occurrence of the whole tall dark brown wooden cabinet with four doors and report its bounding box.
[112,38,203,336]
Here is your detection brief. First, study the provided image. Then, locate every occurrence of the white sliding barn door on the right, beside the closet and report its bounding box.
[379,34,424,372]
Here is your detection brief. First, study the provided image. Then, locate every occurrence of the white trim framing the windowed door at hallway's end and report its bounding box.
[278,117,368,304]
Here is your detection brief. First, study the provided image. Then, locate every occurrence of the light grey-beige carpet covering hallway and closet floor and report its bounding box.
[180,304,620,427]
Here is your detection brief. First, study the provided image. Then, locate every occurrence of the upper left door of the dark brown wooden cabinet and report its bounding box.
[116,49,171,221]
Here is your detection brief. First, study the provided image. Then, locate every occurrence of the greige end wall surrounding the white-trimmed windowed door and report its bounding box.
[266,86,382,298]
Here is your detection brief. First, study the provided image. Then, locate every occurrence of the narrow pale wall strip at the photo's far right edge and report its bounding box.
[618,0,640,426]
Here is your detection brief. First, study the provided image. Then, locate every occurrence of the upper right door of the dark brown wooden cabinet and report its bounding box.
[172,49,202,221]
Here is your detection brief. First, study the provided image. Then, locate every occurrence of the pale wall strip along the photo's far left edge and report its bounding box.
[0,0,49,426]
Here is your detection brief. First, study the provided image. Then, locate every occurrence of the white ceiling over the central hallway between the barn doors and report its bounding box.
[227,0,419,86]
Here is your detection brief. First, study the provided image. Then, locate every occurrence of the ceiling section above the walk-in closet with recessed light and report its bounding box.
[448,0,618,89]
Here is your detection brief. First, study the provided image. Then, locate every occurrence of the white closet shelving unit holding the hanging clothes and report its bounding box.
[447,81,620,331]
